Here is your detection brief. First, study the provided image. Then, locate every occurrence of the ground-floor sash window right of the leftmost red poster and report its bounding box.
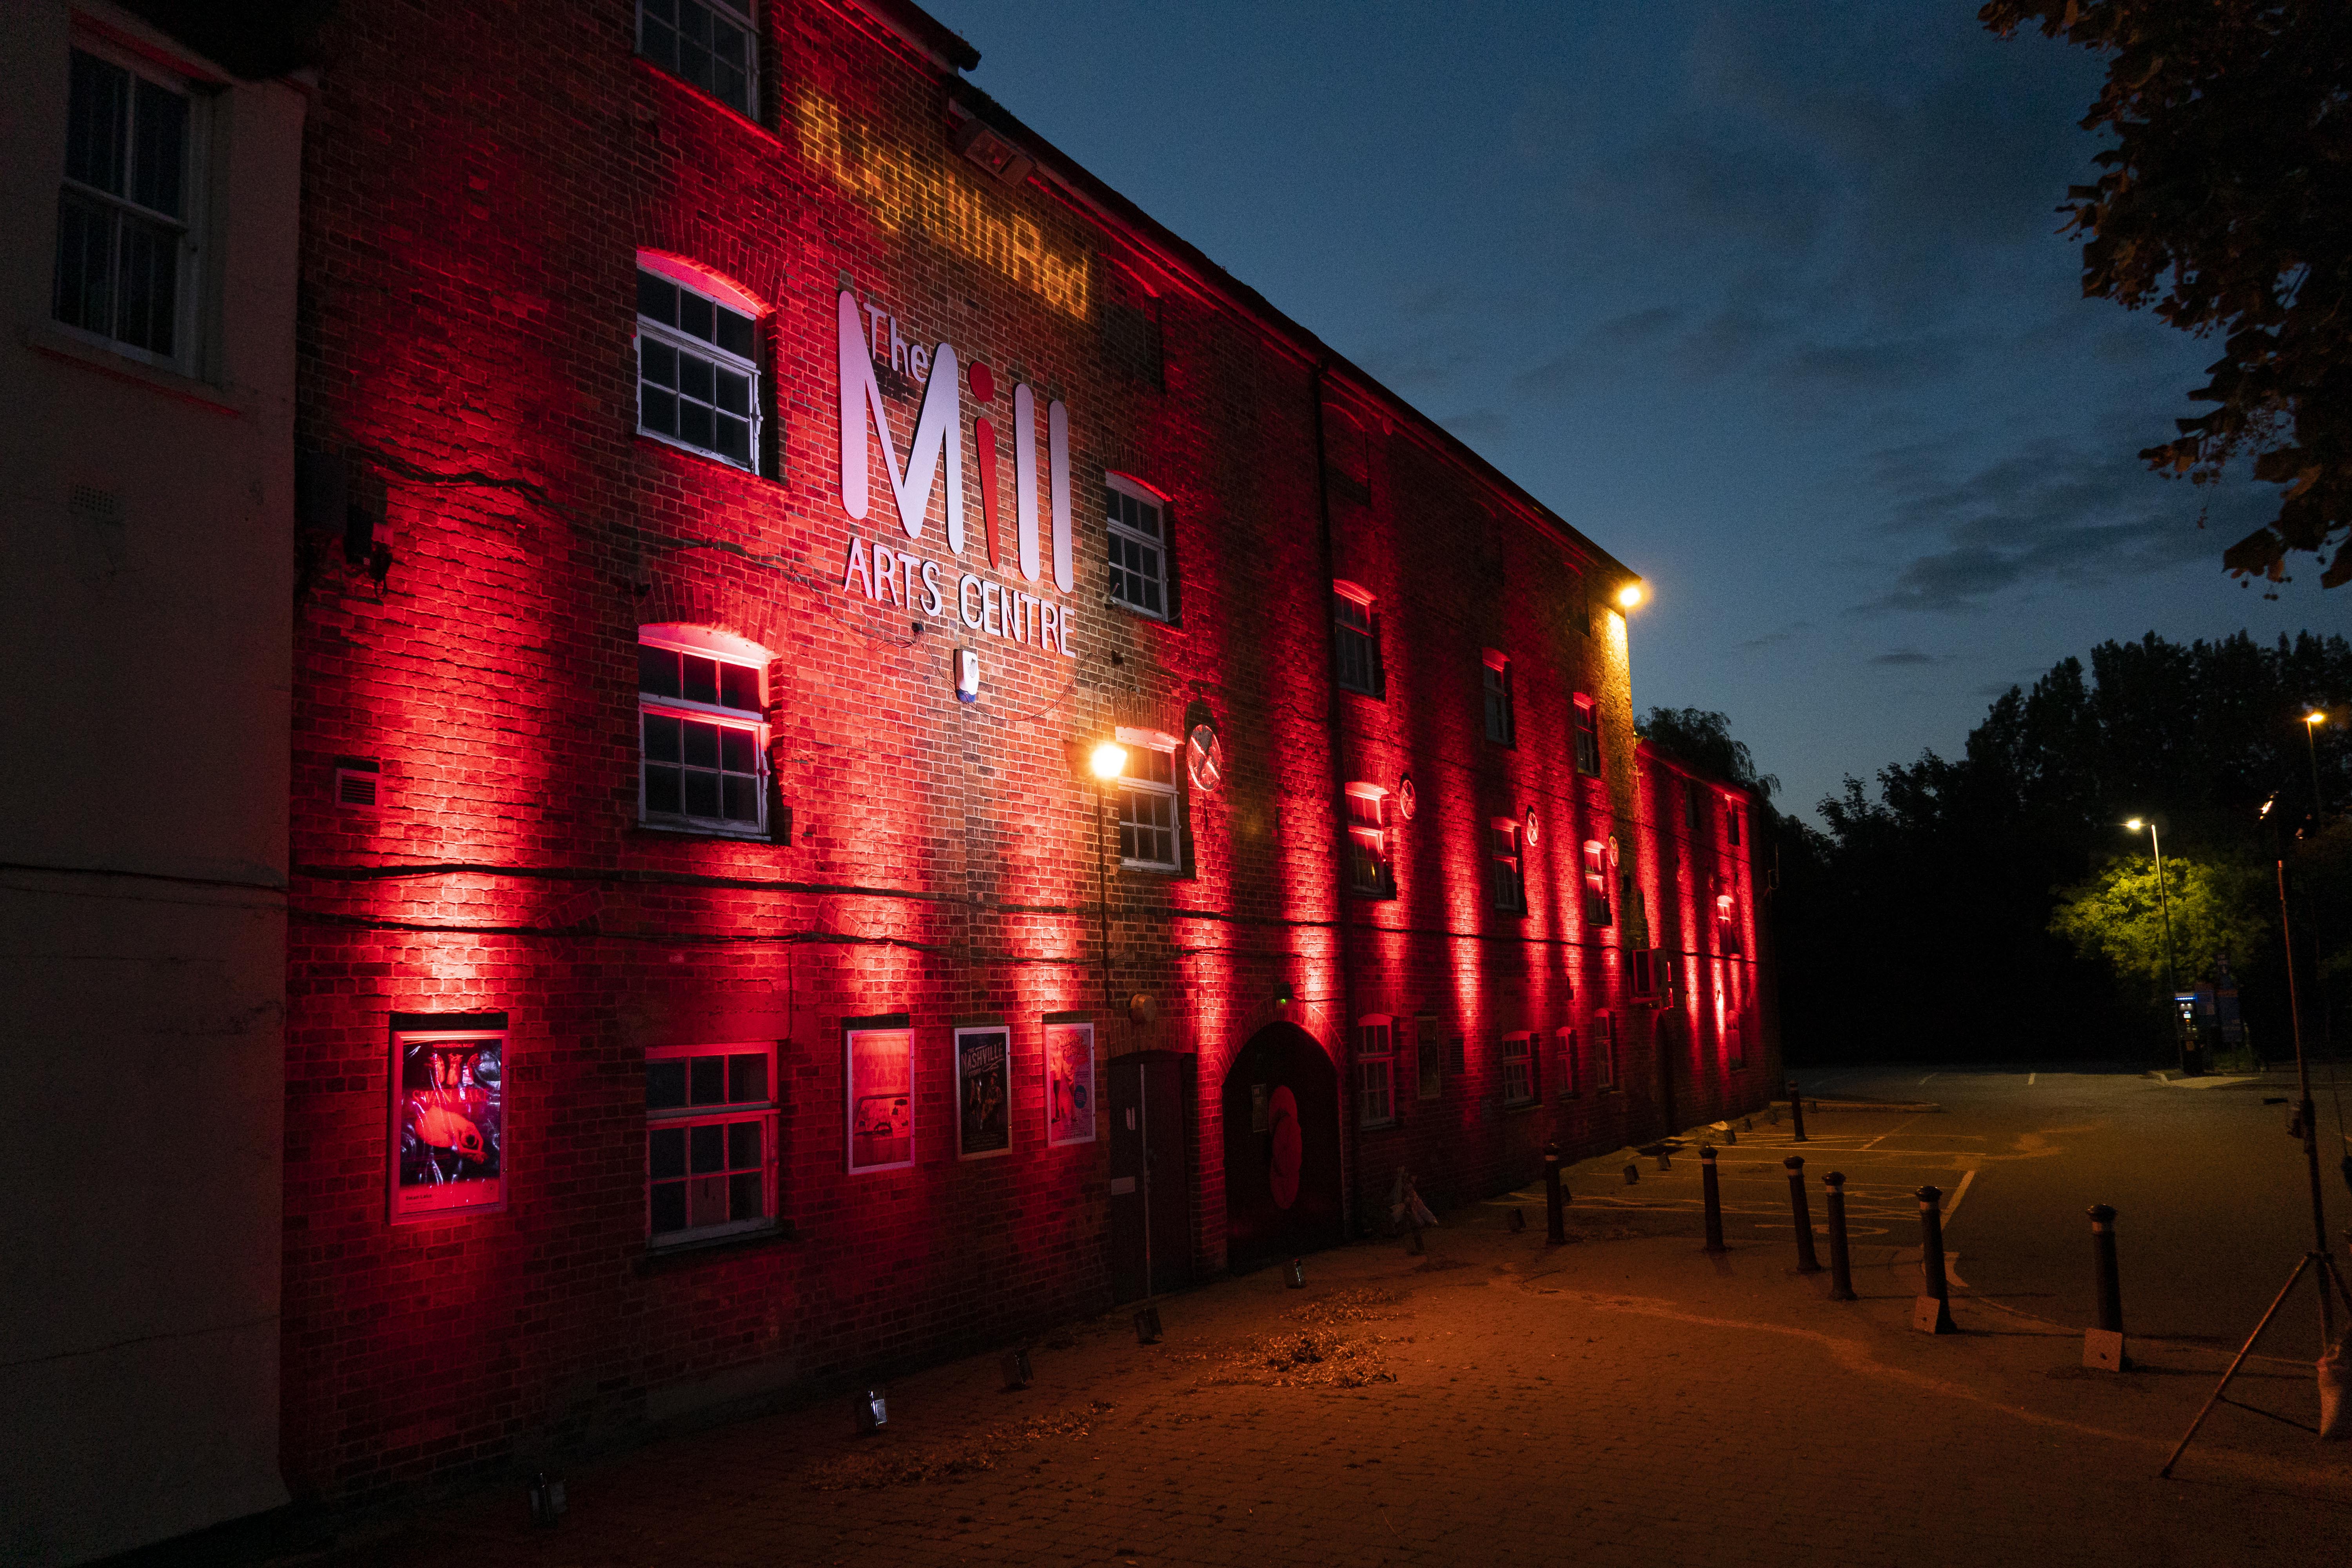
[644,1044,776,1246]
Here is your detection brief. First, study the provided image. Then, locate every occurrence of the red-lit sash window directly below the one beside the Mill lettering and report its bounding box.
[637,625,767,837]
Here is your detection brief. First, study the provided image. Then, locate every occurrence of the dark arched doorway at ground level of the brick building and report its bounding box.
[1223,1023,1345,1269]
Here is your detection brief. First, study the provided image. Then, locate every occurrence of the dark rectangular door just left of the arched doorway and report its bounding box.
[1108,1053,1192,1302]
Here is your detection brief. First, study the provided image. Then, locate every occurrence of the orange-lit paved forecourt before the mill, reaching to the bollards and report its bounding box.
[303,1126,2352,1568]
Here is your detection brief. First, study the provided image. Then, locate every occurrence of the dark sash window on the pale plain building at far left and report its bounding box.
[49,49,200,362]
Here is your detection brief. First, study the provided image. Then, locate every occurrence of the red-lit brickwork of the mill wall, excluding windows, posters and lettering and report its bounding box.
[285,0,1752,1497]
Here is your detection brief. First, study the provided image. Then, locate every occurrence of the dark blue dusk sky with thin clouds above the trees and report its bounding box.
[929,0,2352,813]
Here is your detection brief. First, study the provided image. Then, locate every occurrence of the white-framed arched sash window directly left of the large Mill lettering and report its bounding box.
[637,261,760,472]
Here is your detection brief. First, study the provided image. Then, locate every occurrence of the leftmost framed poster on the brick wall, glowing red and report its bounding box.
[393,1032,506,1225]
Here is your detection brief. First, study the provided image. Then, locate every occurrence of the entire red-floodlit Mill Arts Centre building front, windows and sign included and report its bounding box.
[282,0,1778,1497]
